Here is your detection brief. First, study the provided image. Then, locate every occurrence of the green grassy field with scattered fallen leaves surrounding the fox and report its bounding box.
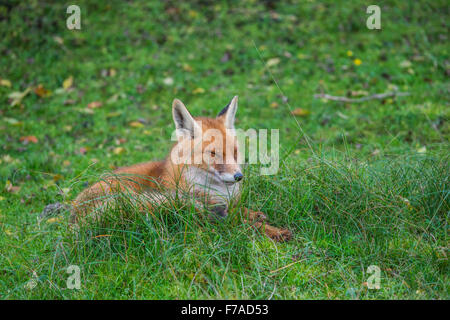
[0,0,450,299]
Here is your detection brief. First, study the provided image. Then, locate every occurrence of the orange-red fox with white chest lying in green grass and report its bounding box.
[71,96,292,242]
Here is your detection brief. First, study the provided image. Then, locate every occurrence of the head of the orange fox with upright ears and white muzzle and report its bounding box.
[171,96,243,184]
